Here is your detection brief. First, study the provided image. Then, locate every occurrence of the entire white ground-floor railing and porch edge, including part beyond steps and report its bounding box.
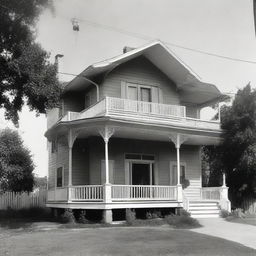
[47,184,230,211]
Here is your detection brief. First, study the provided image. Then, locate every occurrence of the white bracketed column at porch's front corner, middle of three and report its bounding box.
[99,126,114,203]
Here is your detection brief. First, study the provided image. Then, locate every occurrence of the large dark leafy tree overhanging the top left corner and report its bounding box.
[0,0,60,124]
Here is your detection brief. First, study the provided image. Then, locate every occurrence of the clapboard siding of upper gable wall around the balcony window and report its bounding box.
[100,57,180,105]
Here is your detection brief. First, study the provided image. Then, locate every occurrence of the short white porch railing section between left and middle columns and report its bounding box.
[70,185,103,201]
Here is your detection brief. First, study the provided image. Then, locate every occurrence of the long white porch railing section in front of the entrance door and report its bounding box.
[111,185,177,201]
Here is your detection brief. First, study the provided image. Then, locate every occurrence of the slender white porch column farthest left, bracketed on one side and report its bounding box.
[68,129,78,201]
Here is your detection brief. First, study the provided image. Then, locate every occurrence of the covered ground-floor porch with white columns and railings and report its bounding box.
[47,121,230,220]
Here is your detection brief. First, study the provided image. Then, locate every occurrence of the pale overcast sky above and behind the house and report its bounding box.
[0,0,256,176]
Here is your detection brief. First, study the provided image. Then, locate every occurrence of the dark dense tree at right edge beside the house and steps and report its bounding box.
[204,85,256,206]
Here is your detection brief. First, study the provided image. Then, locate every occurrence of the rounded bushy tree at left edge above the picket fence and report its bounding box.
[0,128,34,192]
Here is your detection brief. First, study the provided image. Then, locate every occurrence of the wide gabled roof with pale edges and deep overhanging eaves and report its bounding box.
[64,41,225,104]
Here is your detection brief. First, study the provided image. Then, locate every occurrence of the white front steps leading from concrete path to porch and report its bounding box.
[186,200,220,218]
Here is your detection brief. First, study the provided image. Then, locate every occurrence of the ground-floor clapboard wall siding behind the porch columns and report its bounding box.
[48,137,201,188]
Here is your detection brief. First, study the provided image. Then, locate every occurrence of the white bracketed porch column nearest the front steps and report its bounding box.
[170,133,187,201]
